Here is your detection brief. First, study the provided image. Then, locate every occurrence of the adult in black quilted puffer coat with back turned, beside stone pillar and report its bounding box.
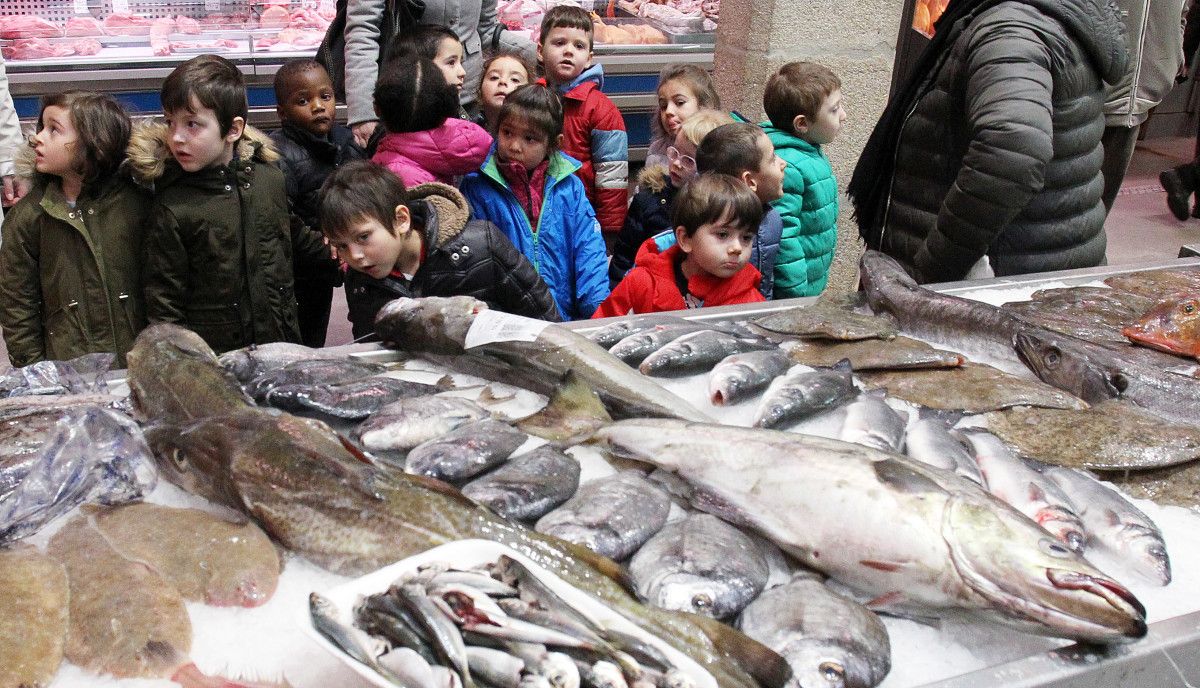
[848,0,1127,282]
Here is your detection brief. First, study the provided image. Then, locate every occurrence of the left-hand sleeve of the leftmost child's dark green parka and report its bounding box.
[0,204,46,367]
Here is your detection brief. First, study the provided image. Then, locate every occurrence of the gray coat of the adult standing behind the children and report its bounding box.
[346,0,534,126]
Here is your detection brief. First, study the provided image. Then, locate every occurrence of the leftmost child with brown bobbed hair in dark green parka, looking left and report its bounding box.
[0,91,150,366]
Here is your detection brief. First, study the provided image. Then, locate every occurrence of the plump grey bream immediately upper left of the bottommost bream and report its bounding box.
[629,514,770,618]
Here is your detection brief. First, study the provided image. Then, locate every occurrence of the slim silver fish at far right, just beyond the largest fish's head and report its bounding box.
[1043,466,1171,586]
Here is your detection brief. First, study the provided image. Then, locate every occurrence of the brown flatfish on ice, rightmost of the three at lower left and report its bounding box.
[92,503,281,606]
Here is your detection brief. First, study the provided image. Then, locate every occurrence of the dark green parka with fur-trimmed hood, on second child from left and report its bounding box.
[130,122,329,352]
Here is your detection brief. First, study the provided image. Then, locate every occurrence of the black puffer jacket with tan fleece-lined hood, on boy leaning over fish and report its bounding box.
[346,183,562,341]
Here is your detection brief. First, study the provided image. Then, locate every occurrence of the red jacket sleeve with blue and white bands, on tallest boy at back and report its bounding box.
[592,91,629,232]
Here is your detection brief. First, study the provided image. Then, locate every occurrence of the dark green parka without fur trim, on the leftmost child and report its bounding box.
[0,149,150,366]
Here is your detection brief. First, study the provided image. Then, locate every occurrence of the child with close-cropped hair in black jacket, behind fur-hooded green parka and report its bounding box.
[271,59,364,347]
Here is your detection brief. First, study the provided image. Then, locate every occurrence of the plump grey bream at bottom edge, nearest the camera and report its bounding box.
[738,574,892,688]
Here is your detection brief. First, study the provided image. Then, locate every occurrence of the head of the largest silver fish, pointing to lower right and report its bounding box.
[942,492,1146,644]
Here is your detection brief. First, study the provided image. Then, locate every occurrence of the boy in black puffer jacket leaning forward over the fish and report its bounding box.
[320,156,559,340]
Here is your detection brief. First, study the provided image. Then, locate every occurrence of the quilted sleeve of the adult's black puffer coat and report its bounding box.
[916,26,1054,282]
